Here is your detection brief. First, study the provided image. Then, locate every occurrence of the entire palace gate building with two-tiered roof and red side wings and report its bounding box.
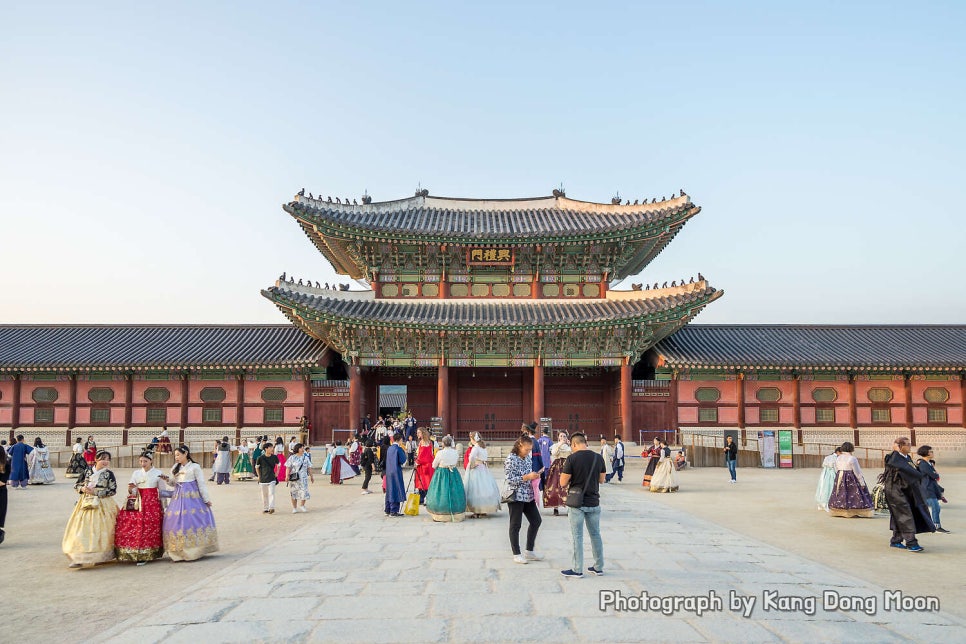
[0,191,966,462]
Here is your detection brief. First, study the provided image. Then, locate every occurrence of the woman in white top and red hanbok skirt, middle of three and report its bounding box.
[114,452,164,566]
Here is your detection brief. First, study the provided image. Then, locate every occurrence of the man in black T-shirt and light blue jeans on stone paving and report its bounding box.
[560,432,607,579]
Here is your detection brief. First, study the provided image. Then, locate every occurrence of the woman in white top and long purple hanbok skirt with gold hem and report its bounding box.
[161,445,218,561]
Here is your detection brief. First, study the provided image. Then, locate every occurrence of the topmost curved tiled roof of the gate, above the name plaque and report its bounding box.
[283,194,701,240]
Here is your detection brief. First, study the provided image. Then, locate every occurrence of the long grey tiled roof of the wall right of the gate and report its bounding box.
[655,324,966,371]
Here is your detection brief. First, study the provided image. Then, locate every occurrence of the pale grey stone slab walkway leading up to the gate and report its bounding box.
[94,482,966,644]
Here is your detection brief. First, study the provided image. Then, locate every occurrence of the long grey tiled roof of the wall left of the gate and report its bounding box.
[0,324,326,371]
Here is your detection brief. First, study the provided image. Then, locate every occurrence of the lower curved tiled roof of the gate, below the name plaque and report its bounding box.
[262,282,722,328]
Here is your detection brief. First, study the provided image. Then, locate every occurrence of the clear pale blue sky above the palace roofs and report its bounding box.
[0,1,966,323]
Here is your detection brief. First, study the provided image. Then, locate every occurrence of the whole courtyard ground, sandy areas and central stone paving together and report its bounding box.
[0,461,966,642]
